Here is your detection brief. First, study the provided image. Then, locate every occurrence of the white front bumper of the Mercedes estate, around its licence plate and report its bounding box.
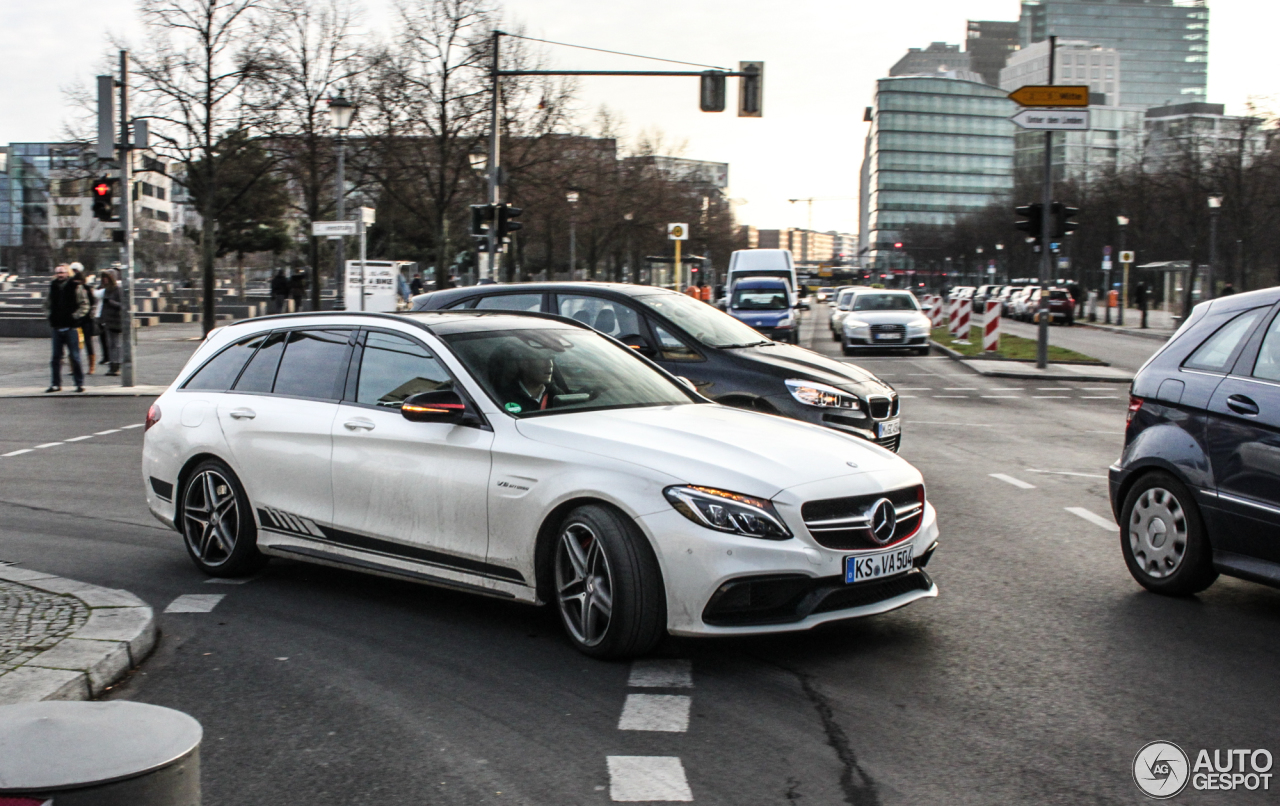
[639,504,938,636]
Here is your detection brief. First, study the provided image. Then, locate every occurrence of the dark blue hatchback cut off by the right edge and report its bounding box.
[1111,288,1280,595]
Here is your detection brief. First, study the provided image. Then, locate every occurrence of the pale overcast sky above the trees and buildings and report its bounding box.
[0,0,1280,233]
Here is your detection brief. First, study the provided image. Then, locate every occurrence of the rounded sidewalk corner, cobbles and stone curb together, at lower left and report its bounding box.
[0,565,156,705]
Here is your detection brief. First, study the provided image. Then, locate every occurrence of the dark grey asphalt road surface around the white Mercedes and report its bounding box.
[0,317,1280,806]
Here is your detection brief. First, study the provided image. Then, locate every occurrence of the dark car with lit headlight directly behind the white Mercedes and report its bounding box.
[412,283,901,450]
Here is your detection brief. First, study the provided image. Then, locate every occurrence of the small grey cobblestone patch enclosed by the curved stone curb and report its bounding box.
[0,580,88,674]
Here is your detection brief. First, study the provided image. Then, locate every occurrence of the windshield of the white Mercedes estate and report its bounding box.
[443,327,701,417]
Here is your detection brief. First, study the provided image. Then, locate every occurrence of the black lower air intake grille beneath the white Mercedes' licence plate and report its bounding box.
[703,567,933,627]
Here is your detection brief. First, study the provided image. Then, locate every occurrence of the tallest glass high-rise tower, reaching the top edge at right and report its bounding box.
[1019,0,1208,107]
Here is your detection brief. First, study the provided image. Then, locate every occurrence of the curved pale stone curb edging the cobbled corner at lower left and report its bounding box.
[0,565,156,705]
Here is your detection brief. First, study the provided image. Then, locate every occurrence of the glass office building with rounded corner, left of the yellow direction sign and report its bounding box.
[859,75,1018,267]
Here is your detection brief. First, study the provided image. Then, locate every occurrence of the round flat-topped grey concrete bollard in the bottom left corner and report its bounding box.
[0,700,204,806]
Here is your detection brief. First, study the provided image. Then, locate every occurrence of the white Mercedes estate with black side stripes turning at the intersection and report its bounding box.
[142,311,938,656]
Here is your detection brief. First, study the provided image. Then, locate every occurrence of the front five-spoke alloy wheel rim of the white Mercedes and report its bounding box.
[556,522,613,646]
